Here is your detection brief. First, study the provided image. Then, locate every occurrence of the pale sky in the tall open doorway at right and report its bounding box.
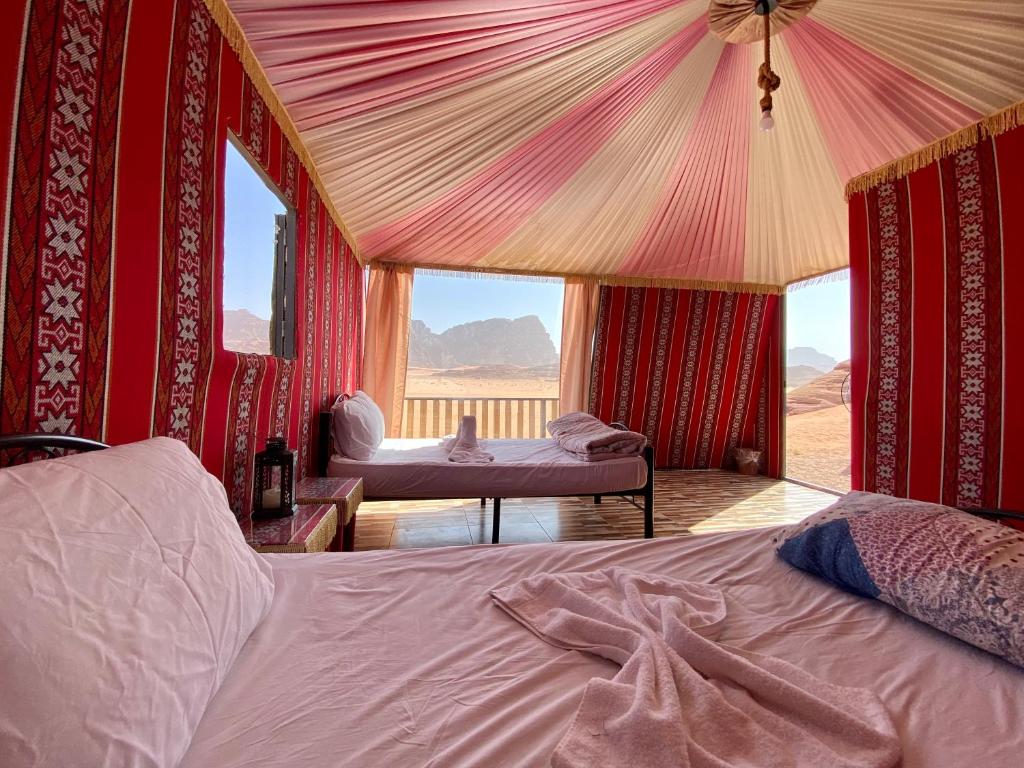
[785,270,850,361]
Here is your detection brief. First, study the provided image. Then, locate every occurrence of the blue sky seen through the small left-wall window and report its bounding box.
[224,141,285,319]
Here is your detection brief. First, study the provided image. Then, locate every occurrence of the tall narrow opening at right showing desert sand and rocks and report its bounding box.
[785,271,850,493]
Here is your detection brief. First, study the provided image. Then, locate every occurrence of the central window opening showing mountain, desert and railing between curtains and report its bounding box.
[402,272,563,437]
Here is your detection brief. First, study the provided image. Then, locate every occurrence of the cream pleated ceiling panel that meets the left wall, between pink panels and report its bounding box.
[307,3,699,231]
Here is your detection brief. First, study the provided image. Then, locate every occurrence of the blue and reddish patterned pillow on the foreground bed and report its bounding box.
[778,497,1024,667]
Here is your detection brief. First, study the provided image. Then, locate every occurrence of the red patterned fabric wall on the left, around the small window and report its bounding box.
[0,0,362,514]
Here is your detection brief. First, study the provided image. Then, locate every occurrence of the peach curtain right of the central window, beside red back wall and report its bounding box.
[558,278,600,414]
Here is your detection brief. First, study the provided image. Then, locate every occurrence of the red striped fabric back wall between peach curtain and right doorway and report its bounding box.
[591,286,782,477]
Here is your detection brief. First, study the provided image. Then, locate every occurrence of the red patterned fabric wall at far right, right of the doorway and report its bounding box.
[850,123,1024,510]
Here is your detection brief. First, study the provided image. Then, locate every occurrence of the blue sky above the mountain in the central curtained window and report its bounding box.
[413,272,563,349]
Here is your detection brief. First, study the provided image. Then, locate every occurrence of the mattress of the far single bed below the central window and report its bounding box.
[328,438,647,499]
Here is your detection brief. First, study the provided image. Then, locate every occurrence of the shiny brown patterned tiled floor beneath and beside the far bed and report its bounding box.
[355,471,836,550]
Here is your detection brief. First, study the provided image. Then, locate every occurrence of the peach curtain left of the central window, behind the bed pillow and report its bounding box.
[362,264,413,437]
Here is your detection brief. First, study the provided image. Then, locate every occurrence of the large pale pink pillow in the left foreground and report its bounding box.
[0,437,273,768]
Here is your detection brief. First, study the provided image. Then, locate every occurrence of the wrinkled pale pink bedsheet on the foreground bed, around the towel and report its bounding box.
[181,528,1024,768]
